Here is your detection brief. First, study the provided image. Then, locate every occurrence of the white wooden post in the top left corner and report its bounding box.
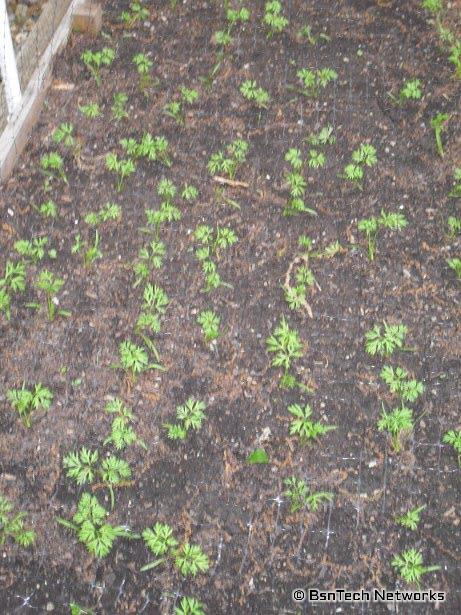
[0,0,22,117]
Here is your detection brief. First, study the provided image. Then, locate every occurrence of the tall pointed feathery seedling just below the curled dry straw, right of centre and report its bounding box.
[266,316,303,388]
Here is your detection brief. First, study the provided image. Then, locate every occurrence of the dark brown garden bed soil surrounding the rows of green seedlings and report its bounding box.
[0,0,461,615]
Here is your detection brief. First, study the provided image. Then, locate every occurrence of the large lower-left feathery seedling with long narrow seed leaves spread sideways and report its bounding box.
[57,493,135,558]
